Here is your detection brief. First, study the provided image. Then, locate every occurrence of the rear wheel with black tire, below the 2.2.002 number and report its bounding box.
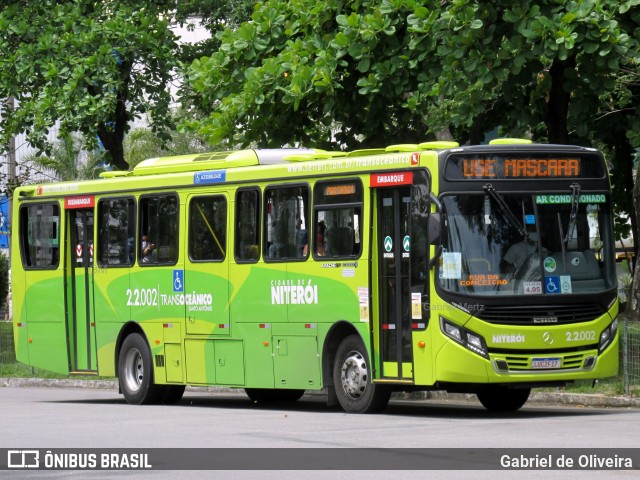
[118,333,162,405]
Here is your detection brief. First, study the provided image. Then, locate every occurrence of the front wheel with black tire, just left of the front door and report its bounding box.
[333,335,391,413]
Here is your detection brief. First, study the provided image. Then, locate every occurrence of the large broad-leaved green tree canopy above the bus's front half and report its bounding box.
[186,0,640,251]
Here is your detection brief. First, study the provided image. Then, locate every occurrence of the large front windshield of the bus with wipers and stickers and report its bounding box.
[438,189,615,296]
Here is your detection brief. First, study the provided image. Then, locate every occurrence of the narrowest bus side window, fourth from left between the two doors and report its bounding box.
[235,188,260,262]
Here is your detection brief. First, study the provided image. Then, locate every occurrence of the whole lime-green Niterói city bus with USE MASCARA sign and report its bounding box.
[11,139,618,413]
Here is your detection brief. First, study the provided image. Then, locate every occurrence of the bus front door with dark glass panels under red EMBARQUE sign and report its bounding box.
[371,171,429,383]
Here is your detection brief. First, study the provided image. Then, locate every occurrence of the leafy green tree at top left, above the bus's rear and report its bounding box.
[0,0,177,169]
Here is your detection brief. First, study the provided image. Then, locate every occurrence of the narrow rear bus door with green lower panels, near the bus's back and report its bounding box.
[65,207,98,374]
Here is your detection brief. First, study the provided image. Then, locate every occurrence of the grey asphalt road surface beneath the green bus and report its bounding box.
[0,387,640,480]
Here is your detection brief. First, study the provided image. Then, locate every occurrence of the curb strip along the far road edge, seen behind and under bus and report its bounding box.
[0,378,640,408]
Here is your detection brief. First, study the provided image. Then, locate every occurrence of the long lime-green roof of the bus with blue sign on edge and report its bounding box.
[16,141,595,198]
